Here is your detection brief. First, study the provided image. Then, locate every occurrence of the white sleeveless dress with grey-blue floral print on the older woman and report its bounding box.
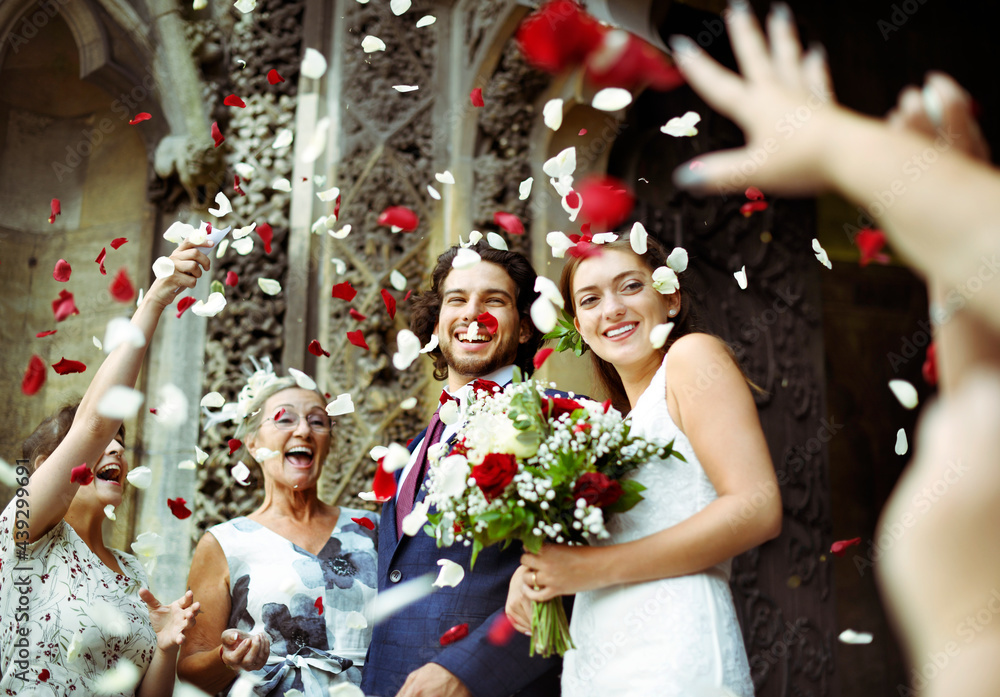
[208,507,379,697]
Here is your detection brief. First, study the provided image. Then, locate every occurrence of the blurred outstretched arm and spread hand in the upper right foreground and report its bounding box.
[671,2,1000,330]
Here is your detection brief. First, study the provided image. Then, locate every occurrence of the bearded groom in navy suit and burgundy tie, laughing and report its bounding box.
[361,244,561,697]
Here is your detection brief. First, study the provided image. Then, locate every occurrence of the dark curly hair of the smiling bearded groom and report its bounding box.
[410,241,542,380]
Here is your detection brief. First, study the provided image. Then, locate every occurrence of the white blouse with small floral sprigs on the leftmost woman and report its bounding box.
[0,499,156,697]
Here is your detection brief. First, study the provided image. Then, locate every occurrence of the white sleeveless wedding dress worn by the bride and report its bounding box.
[562,359,754,697]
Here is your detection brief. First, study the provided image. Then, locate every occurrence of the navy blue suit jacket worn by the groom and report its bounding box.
[361,391,565,697]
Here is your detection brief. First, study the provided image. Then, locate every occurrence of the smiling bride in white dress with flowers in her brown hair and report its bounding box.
[507,238,781,697]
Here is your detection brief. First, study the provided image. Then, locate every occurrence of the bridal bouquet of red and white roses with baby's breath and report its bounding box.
[415,370,680,656]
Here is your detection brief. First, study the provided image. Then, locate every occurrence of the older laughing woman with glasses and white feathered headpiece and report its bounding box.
[178,369,379,697]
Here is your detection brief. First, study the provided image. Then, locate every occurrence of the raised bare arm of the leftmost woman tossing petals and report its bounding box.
[27,241,209,542]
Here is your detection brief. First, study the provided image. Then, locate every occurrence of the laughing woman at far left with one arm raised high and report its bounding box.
[0,242,209,697]
